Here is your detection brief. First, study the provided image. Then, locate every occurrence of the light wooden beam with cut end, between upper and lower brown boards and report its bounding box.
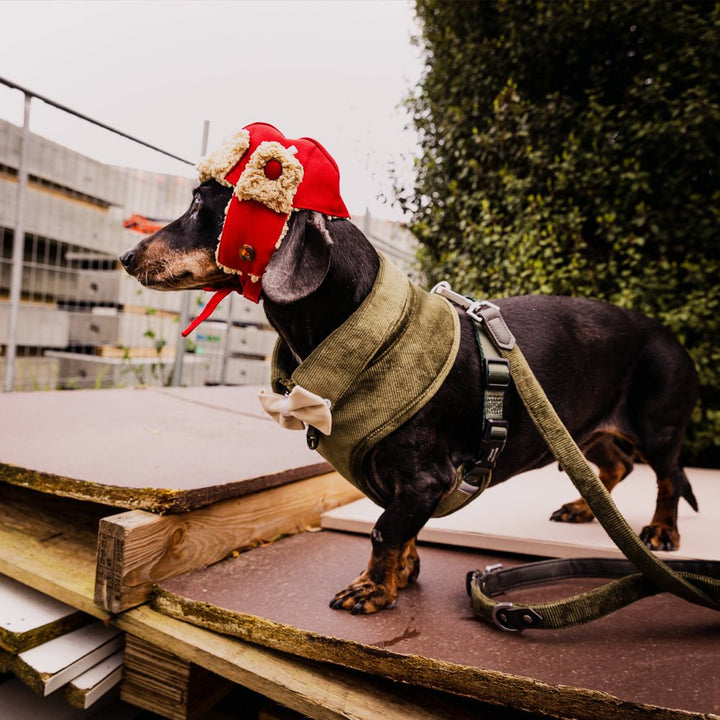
[95,472,361,613]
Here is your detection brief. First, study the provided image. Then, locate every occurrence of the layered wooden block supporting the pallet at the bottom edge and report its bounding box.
[121,636,234,720]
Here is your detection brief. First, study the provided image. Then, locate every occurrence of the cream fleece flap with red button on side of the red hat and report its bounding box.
[235,141,303,214]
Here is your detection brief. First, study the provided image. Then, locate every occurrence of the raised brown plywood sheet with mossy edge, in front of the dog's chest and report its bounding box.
[0,387,331,512]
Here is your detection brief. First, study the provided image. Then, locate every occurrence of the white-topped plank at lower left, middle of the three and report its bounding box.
[13,622,125,696]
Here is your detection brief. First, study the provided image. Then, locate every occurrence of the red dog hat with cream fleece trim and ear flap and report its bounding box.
[197,123,350,302]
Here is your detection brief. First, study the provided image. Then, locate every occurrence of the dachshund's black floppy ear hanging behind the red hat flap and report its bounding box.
[262,210,333,305]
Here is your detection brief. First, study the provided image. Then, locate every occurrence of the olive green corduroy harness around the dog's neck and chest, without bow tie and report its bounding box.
[272,256,460,504]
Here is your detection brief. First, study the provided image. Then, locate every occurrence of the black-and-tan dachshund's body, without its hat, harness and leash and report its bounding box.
[121,179,697,613]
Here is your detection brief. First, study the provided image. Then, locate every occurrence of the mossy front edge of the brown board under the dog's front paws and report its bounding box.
[151,587,717,720]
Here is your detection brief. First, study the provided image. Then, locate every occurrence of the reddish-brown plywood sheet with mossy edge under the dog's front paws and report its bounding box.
[154,531,720,720]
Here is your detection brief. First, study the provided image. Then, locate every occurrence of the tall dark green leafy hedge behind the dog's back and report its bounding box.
[396,0,720,466]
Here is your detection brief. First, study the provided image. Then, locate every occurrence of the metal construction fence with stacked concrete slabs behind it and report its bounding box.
[0,78,413,391]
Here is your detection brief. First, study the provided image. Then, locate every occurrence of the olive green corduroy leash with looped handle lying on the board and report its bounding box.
[433,283,720,632]
